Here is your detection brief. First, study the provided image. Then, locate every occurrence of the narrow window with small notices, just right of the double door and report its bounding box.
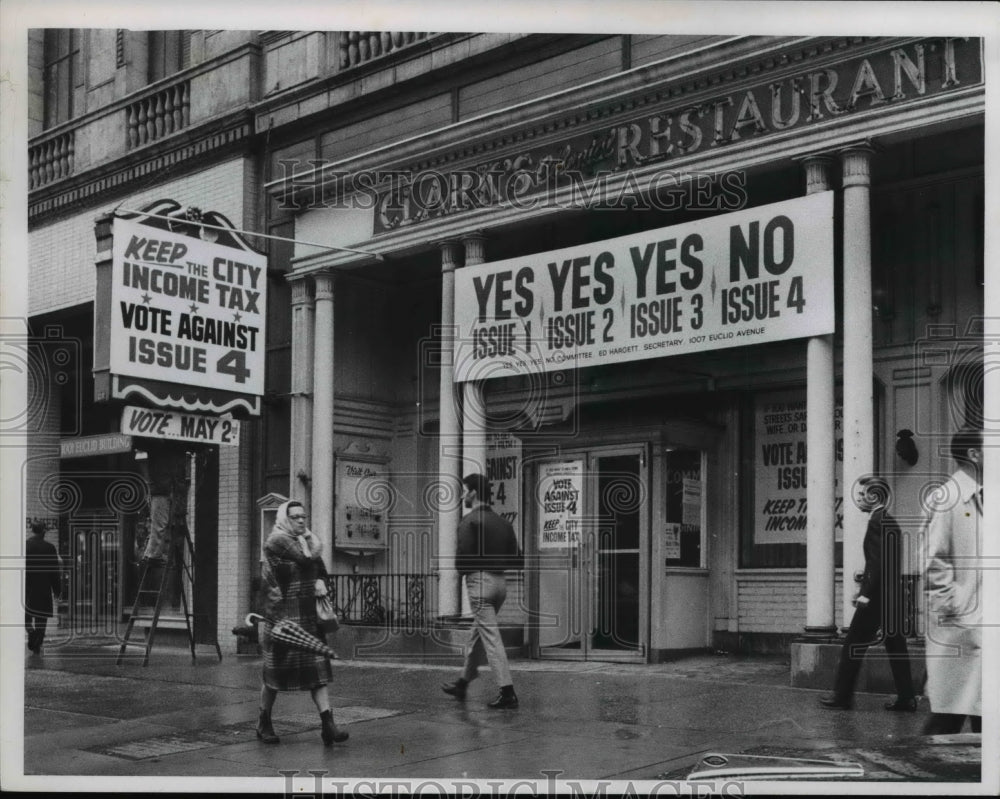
[663,448,705,568]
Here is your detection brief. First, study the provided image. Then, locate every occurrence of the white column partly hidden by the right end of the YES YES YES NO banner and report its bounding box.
[803,156,837,636]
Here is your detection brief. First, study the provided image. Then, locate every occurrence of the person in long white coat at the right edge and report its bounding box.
[924,427,983,735]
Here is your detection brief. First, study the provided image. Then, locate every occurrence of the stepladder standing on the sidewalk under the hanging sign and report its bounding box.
[115,500,222,666]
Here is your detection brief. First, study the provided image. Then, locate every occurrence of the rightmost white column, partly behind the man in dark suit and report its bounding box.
[841,144,875,627]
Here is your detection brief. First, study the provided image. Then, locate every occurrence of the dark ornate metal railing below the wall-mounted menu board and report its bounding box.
[327,574,434,630]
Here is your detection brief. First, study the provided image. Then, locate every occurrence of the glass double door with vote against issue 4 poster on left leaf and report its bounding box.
[533,446,649,660]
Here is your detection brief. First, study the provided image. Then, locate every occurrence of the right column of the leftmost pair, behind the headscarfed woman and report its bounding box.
[310,272,334,568]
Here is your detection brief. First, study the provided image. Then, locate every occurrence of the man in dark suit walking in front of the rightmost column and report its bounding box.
[820,476,917,712]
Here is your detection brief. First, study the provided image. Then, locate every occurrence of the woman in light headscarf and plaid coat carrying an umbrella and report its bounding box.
[257,500,349,746]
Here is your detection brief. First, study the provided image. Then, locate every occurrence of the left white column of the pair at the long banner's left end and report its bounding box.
[437,241,462,616]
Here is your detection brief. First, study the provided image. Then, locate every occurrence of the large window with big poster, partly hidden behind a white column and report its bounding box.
[740,388,844,569]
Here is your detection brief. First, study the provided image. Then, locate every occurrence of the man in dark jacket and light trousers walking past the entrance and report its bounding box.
[442,474,522,710]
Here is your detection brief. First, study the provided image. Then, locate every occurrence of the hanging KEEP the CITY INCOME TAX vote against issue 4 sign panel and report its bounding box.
[111,219,267,395]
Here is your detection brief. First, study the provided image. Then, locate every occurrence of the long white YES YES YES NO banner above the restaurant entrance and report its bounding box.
[454,192,834,381]
